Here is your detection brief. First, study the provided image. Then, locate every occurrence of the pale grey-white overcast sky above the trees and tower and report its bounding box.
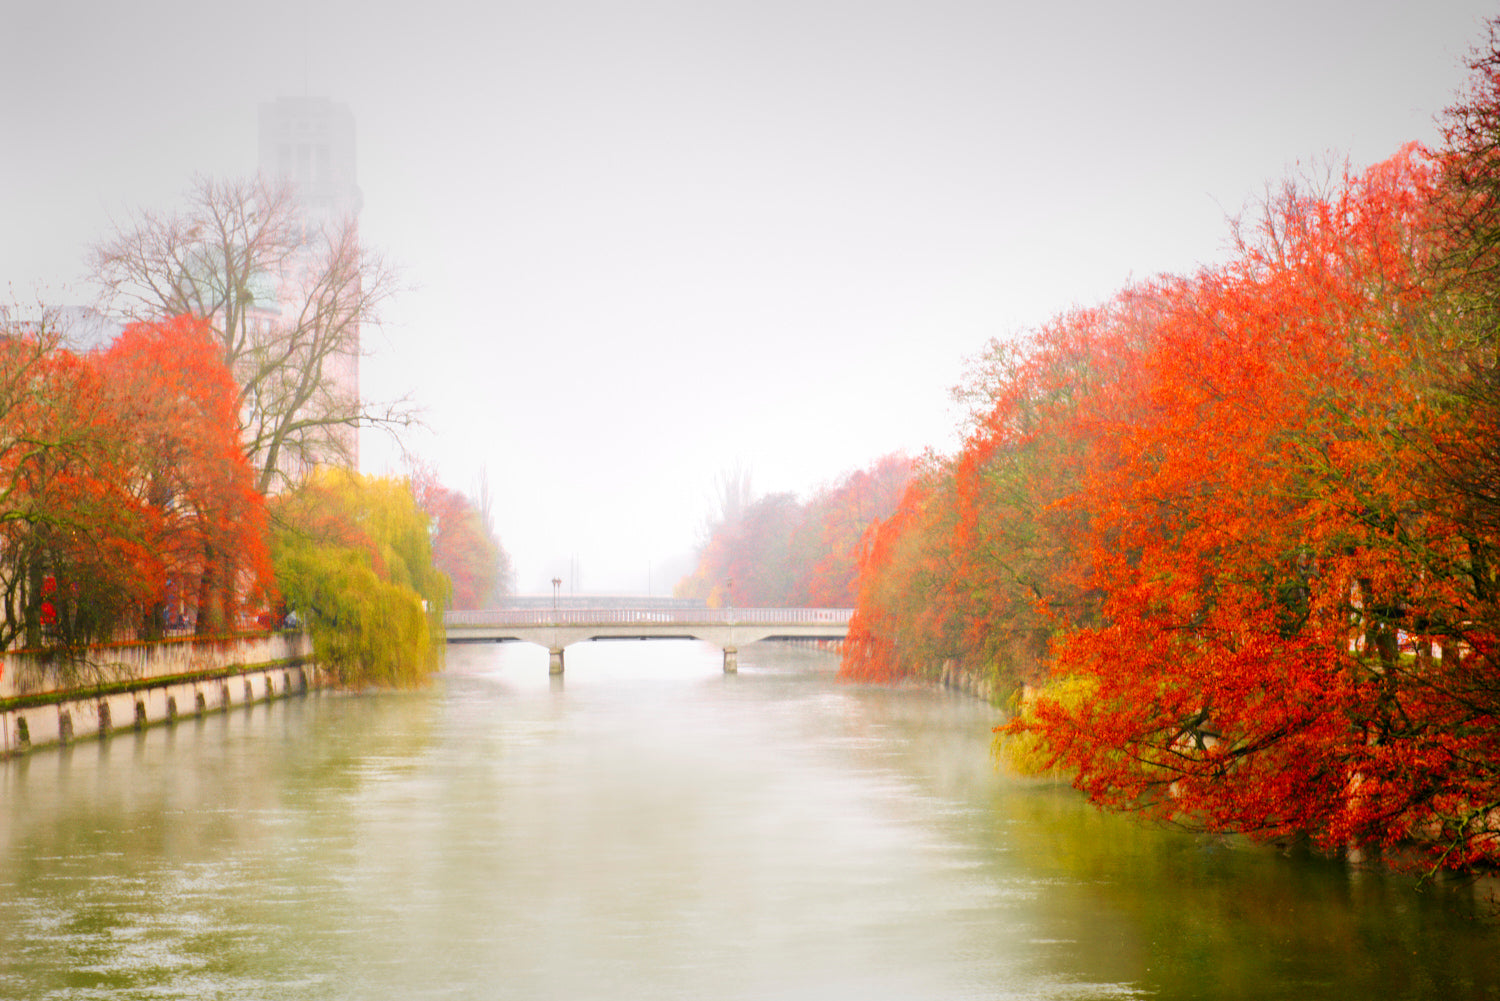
[0,0,1500,594]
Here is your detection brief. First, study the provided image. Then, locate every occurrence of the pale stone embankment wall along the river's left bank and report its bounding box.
[0,633,324,758]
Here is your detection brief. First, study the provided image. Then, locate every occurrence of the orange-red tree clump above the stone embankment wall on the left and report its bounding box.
[0,318,270,648]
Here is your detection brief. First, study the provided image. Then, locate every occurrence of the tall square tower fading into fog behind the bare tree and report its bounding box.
[260,98,365,468]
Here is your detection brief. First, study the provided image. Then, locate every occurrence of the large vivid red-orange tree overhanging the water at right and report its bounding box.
[1011,150,1500,864]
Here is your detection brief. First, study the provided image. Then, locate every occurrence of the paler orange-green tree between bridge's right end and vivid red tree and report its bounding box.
[842,309,1133,690]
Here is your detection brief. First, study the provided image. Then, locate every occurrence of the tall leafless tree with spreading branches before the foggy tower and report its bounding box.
[90,177,414,492]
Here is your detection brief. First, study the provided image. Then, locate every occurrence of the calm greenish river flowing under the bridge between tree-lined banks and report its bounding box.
[0,641,1500,1001]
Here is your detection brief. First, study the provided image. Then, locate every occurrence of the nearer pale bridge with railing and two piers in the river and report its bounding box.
[443,608,854,674]
